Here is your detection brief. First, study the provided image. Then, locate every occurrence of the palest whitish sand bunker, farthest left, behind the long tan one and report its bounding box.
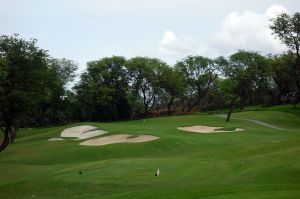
[60,125,107,140]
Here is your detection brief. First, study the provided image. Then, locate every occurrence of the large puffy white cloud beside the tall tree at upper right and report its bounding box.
[212,5,288,54]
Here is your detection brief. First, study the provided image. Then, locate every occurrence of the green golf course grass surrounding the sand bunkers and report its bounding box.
[0,110,300,199]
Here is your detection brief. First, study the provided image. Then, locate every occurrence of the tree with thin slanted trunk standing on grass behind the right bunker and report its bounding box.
[222,50,269,121]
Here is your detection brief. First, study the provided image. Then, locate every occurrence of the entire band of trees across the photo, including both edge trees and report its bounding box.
[0,13,300,151]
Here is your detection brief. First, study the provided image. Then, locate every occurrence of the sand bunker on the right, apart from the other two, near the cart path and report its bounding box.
[177,125,244,133]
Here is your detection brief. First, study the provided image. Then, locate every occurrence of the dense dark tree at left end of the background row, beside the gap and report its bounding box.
[75,56,130,121]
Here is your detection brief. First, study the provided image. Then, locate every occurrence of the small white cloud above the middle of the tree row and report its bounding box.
[159,30,206,56]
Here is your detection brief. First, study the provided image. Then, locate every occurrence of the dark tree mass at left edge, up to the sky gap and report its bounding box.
[0,35,76,150]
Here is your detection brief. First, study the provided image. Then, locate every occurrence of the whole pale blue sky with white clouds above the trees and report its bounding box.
[0,0,300,73]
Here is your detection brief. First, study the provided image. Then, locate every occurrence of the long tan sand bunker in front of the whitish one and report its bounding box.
[80,134,159,146]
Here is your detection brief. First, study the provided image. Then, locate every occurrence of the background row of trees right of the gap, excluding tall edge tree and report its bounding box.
[73,50,299,121]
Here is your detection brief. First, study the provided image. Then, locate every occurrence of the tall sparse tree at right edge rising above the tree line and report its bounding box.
[270,12,300,101]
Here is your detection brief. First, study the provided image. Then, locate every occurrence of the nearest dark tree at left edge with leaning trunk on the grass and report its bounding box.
[0,35,48,151]
